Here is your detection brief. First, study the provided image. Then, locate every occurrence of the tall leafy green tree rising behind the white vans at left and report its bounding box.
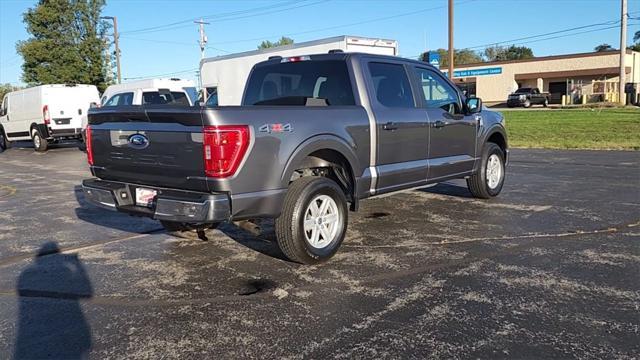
[16,0,111,91]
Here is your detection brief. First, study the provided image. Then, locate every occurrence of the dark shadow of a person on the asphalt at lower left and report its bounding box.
[14,242,93,359]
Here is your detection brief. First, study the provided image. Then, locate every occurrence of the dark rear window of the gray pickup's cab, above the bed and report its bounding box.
[243,60,355,106]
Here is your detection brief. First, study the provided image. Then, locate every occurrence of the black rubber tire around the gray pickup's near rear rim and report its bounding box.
[275,177,348,265]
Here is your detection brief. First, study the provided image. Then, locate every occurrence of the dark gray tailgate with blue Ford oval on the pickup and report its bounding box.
[89,106,209,192]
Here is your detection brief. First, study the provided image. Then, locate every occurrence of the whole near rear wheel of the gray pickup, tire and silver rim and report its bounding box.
[275,177,348,265]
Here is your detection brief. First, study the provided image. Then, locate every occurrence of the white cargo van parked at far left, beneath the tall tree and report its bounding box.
[0,84,100,151]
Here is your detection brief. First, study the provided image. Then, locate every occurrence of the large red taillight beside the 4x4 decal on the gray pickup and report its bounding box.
[203,125,249,178]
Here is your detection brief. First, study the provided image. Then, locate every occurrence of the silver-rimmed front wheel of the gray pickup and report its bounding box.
[467,143,505,199]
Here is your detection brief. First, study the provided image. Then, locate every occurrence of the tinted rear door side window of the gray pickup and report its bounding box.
[369,62,416,108]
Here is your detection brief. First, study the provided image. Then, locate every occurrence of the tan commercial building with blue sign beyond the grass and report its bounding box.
[442,50,640,105]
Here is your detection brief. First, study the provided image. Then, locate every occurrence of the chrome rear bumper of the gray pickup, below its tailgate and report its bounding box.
[82,179,231,223]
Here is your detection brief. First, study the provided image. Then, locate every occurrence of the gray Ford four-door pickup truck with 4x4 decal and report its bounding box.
[83,52,508,264]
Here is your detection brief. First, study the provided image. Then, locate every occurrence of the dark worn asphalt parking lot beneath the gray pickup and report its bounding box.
[0,145,640,359]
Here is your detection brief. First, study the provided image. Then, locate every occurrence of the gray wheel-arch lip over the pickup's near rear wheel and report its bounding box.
[280,134,360,188]
